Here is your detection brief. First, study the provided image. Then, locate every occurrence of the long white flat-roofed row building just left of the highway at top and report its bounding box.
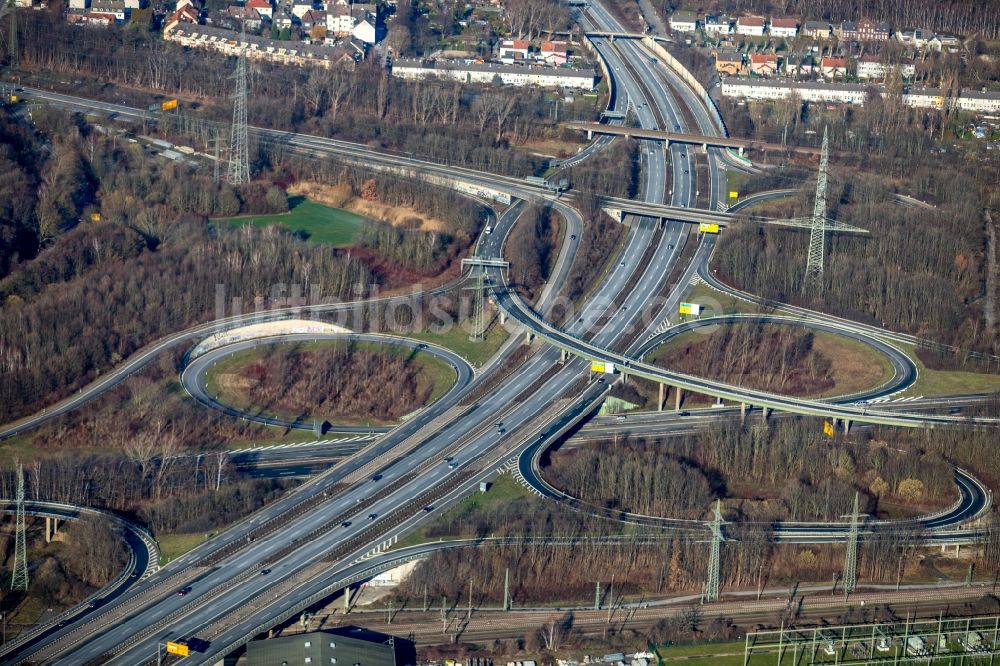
[392,58,596,90]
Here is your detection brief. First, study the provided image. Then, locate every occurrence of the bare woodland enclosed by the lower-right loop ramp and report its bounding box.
[546,420,955,521]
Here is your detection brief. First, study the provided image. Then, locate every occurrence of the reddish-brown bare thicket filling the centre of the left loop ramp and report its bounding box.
[225,344,444,421]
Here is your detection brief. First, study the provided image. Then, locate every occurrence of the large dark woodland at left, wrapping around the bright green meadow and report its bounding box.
[0,110,483,421]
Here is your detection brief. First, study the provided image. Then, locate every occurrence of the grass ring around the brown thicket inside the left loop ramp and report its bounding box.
[205,340,456,426]
